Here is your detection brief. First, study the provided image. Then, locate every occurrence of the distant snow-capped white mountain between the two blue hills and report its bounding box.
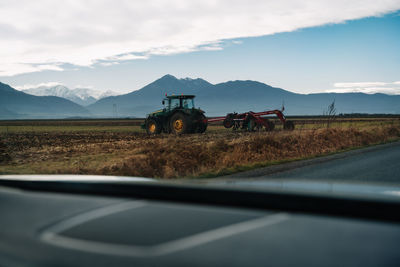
[22,85,117,106]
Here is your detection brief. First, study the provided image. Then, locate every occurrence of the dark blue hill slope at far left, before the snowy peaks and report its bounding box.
[0,82,91,119]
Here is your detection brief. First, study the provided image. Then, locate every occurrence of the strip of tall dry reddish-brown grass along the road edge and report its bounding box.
[105,127,400,178]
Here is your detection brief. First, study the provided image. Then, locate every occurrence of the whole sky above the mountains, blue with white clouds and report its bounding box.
[0,0,400,94]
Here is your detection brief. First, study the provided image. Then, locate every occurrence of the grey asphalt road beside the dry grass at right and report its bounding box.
[226,142,400,184]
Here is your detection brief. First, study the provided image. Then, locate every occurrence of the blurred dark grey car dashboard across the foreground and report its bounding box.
[0,179,400,266]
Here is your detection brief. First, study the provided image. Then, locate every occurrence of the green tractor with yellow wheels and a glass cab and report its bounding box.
[141,95,208,134]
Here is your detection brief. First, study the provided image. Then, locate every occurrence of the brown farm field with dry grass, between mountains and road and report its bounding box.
[0,118,400,178]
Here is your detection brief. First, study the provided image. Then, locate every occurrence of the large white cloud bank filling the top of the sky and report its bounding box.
[0,0,400,76]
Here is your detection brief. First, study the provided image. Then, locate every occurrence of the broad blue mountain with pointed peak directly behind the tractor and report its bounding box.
[87,75,400,117]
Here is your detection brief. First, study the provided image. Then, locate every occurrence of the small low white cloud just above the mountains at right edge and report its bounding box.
[327,81,400,95]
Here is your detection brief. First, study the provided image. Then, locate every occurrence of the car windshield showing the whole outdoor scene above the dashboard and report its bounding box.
[0,1,400,199]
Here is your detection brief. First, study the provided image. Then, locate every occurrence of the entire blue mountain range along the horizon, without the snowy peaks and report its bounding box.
[0,75,400,118]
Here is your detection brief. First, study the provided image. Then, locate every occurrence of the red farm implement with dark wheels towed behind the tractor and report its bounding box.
[207,109,294,131]
